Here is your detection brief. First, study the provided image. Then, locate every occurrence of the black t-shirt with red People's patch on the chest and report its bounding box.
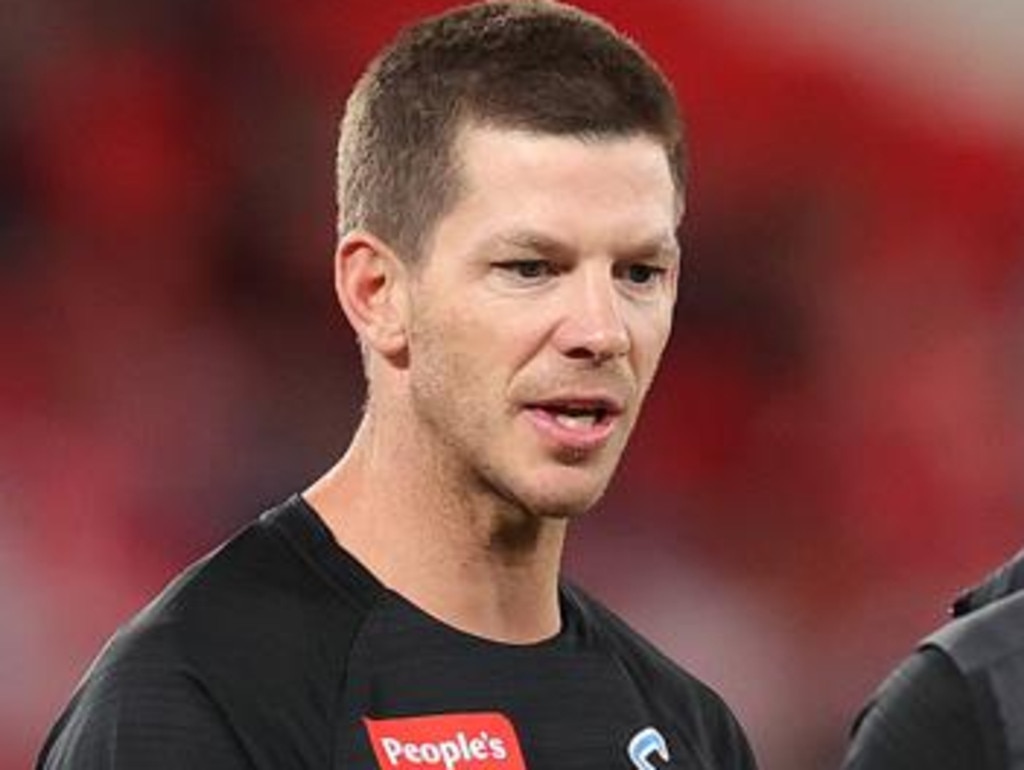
[37,497,755,770]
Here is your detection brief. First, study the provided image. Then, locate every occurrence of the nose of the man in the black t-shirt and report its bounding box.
[555,270,631,363]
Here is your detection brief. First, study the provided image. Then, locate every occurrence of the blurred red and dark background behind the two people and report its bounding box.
[6,0,1024,770]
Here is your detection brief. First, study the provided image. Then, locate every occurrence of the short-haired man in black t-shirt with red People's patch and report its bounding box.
[39,2,754,770]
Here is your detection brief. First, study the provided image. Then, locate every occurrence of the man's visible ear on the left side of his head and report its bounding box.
[334,230,409,360]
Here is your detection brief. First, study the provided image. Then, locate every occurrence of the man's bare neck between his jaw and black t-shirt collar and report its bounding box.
[305,414,565,644]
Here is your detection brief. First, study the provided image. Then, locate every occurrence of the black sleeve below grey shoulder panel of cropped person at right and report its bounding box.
[843,647,1007,770]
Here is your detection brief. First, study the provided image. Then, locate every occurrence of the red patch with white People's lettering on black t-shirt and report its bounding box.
[362,713,526,770]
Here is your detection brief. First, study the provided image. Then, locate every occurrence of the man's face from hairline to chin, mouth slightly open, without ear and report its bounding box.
[408,127,679,517]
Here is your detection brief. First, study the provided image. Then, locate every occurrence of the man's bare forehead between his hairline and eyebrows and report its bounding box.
[439,126,682,252]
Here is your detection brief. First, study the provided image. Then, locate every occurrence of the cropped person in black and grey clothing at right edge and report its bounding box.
[844,552,1024,770]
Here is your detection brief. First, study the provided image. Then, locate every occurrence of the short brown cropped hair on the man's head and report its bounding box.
[338,0,685,259]
